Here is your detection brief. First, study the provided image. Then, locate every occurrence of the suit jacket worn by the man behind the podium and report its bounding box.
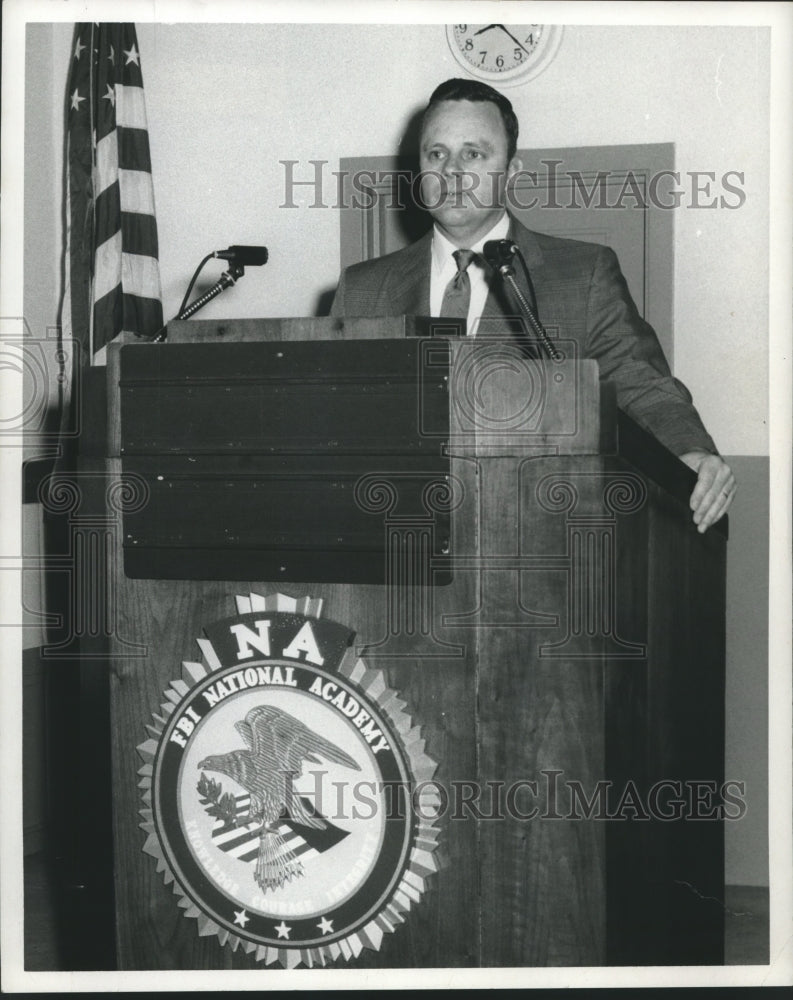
[331,219,716,455]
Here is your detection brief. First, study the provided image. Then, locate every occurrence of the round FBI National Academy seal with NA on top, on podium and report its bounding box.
[138,594,439,968]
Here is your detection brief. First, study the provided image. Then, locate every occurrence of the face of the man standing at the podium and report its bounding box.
[419,101,520,247]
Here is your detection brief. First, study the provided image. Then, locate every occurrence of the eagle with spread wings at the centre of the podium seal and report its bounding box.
[198,705,360,892]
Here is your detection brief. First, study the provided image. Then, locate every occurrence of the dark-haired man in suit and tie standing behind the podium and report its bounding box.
[331,79,736,531]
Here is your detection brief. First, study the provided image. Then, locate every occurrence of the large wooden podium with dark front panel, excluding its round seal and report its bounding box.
[58,318,726,969]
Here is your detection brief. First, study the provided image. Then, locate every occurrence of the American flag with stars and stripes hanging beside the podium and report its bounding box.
[61,24,162,362]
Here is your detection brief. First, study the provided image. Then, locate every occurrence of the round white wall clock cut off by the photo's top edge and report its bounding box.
[446,24,562,85]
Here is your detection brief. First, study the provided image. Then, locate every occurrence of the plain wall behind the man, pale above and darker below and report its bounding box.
[25,24,768,884]
